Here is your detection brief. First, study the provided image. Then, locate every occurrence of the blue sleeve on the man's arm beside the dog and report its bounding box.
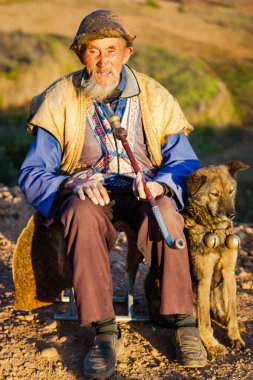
[154,133,200,211]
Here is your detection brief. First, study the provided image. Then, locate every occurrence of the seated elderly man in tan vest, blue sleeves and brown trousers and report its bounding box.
[19,10,206,378]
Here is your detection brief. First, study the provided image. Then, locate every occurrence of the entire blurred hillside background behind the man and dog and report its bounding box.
[0,0,253,221]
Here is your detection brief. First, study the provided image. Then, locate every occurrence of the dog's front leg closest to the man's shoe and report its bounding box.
[197,255,227,355]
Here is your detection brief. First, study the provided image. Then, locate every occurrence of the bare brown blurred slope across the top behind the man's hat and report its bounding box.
[0,0,253,58]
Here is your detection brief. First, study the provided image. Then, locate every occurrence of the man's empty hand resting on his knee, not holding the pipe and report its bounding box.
[64,178,110,206]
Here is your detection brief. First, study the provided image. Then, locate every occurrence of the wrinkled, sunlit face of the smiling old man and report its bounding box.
[84,38,133,87]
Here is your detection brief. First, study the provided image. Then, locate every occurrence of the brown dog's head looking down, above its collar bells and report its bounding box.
[186,161,249,224]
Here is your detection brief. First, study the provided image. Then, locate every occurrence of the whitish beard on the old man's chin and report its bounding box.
[83,70,118,101]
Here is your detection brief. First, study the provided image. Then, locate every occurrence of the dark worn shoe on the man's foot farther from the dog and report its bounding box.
[84,331,124,379]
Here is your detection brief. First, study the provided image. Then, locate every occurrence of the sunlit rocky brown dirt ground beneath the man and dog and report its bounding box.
[0,186,253,380]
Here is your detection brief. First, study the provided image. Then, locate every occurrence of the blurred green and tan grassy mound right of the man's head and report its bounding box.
[131,44,240,127]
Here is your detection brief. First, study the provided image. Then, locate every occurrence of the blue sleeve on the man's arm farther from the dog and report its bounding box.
[18,128,66,218]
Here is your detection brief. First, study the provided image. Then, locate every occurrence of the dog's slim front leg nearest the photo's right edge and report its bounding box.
[222,253,245,348]
